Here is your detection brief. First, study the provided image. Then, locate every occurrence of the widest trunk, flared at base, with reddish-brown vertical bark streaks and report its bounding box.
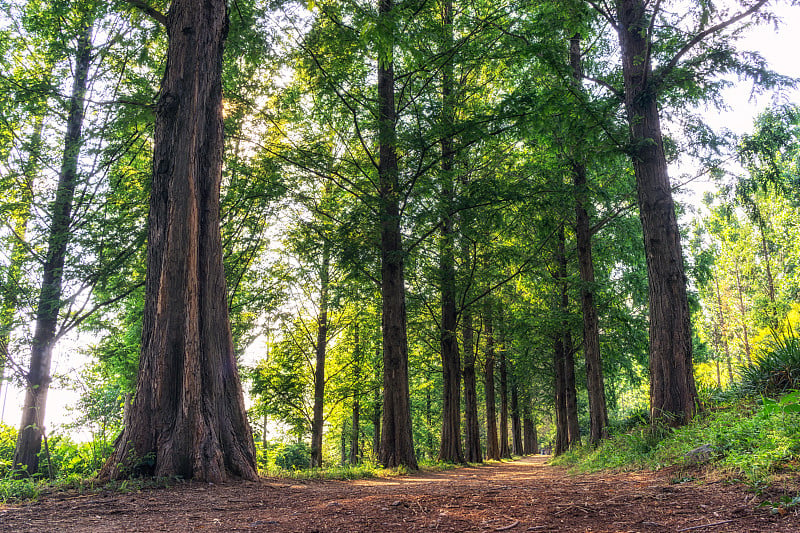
[101,0,258,483]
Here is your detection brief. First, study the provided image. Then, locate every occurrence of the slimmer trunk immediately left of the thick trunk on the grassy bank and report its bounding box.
[570,35,608,445]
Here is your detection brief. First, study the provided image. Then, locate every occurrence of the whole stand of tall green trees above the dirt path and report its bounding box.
[0,0,800,490]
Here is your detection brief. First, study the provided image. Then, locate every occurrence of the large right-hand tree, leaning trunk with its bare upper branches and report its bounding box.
[604,0,767,426]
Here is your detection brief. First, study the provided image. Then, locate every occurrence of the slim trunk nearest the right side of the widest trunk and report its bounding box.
[310,239,331,468]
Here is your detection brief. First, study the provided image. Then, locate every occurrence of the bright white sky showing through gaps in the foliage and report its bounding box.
[0,0,800,439]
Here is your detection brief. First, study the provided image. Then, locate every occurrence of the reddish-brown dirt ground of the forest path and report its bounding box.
[0,456,800,533]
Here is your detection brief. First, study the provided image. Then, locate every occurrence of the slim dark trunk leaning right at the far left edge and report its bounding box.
[13,23,92,475]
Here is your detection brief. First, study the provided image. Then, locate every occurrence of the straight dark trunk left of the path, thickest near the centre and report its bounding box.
[378,0,417,470]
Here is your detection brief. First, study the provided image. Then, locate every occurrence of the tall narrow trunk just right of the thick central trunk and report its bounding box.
[439,0,465,463]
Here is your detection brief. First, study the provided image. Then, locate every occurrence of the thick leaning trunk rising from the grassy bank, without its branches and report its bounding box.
[616,0,697,426]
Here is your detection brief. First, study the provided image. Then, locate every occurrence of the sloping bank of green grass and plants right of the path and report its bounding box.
[552,395,800,486]
